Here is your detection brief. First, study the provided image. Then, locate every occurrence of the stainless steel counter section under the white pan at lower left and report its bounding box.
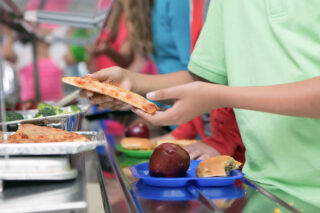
[0,152,100,213]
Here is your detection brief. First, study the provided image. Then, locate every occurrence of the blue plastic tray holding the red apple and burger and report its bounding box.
[130,160,244,187]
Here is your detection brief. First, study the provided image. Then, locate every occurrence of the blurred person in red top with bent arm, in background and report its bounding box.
[83,0,157,74]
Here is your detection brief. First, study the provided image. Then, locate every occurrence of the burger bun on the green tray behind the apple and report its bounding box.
[120,137,155,150]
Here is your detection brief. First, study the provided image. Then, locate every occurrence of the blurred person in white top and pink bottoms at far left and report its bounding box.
[2,28,66,105]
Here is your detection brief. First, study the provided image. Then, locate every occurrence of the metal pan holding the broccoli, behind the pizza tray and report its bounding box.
[0,104,89,131]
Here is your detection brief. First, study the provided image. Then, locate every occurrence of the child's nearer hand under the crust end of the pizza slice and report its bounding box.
[133,82,220,126]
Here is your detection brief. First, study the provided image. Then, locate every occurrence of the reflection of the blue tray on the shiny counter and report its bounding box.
[131,180,245,201]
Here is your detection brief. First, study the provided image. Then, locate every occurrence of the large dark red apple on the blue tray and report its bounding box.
[149,143,190,177]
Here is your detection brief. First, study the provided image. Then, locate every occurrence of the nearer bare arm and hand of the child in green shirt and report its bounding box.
[134,77,320,125]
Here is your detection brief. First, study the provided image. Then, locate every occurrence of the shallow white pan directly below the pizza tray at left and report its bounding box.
[0,156,78,181]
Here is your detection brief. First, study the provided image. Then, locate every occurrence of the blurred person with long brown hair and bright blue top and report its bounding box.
[123,0,190,74]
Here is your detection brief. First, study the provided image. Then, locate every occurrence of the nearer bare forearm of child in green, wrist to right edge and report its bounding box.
[212,77,320,118]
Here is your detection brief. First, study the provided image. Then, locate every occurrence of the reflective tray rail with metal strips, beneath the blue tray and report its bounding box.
[98,136,320,213]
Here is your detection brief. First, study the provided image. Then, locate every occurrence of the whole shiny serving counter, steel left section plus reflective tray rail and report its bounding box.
[0,136,320,213]
